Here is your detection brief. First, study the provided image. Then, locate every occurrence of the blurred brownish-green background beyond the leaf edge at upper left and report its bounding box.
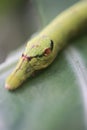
[0,0,40,63]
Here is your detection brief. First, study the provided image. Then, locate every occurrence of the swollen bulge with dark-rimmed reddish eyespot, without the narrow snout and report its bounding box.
[22,36,54,70]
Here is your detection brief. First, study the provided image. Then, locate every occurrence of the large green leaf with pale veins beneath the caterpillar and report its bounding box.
[0,0,87,130]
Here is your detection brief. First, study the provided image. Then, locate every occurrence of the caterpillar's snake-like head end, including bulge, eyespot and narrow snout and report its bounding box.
[6,36,54,89]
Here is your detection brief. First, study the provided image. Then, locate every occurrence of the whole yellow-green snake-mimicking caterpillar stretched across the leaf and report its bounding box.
[6,1,87,90]
